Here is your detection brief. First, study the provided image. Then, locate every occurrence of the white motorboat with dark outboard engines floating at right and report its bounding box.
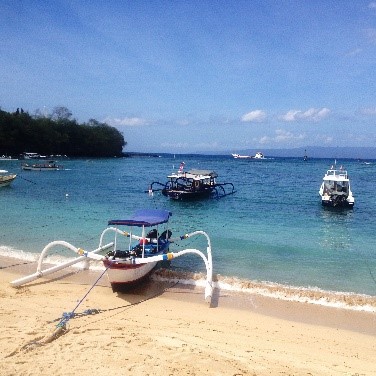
[319,163,355,208]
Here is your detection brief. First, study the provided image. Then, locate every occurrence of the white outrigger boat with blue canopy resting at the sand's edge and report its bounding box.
[11,209,213,302]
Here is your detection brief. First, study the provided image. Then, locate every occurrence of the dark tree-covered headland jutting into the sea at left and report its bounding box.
[0,107,126,157]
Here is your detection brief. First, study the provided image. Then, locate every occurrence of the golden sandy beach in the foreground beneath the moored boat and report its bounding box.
[0,260,376,376]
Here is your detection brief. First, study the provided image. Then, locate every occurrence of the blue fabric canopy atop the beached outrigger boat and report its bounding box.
[108,209,172,227]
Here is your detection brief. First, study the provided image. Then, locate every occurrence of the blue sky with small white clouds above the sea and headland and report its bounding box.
[0,0,376,153]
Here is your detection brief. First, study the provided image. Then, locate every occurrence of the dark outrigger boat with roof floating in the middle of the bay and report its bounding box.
[148,162,236,201]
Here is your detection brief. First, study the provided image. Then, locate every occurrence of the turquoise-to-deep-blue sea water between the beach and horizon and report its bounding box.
[0,155,376,308]
